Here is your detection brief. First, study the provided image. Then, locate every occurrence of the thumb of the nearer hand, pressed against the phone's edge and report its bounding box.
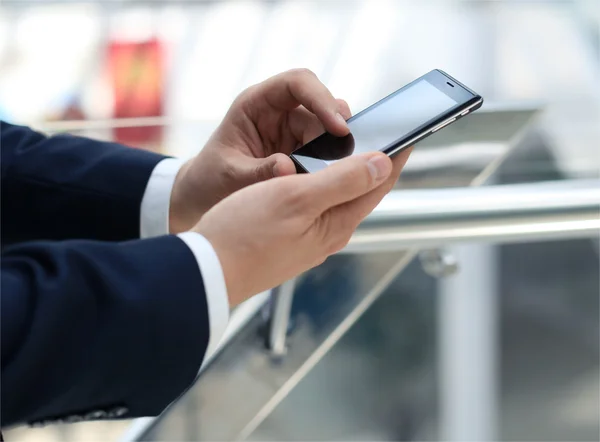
[306,152,392,213]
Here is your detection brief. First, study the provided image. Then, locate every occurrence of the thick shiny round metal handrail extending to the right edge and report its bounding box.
[343,180,600,253]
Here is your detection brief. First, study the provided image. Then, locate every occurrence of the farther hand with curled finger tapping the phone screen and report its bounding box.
[169,69,351,233]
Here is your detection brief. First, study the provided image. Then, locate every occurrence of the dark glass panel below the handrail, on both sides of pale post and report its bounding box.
[251,240,600,441]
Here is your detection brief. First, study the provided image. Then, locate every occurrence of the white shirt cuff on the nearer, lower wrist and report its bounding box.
[177,232,229,361]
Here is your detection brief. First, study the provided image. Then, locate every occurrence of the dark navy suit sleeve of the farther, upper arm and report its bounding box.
[0,122,166,245]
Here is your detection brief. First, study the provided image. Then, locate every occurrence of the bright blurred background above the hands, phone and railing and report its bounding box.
[0,0,600,174]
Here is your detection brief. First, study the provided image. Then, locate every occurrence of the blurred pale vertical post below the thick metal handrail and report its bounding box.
[438,243,498,442]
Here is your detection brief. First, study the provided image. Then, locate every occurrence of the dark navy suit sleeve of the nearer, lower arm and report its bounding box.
[1,236,209,426]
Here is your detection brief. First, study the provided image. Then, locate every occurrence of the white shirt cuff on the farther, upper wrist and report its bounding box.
[140,158,184,238]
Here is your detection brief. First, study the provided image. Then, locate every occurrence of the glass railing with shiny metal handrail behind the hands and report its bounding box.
[7,100,600,442]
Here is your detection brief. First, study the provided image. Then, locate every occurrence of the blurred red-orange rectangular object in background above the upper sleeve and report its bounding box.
[108,39,164,150]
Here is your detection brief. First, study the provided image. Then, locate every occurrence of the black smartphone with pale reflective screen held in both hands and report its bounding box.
[291,69,483,173]
